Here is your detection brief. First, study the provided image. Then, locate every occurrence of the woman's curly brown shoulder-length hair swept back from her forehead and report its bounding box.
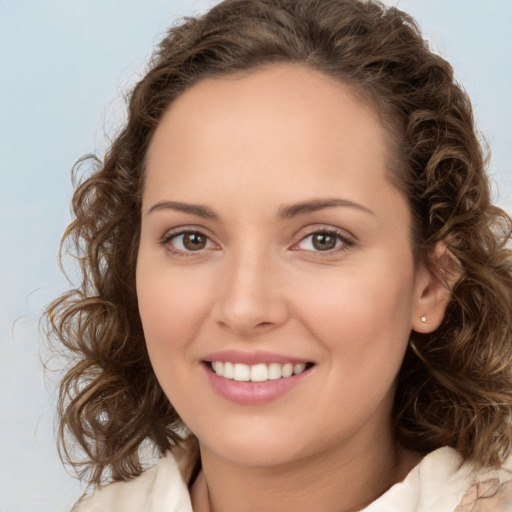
[46,0,512,484]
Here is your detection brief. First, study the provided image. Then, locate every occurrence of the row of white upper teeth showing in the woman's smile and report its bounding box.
[211,361,306,382]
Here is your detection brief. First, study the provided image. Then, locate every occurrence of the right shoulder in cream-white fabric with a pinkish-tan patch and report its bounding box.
[364,447,512,512]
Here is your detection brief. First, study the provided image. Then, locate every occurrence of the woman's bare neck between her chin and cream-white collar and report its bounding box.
[192,432,419,512]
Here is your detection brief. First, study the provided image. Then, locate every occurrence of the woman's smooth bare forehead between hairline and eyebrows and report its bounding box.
[145,65,396,214]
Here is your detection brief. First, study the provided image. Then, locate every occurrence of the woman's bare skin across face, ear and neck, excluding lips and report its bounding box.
[137,65,449,512]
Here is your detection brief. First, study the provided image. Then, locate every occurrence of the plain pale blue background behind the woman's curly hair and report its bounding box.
[0,0,512,512]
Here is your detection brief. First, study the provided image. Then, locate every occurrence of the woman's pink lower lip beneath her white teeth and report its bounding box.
[203,365,311,405]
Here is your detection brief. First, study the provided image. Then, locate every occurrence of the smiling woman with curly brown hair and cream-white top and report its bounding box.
[48,0,512,512]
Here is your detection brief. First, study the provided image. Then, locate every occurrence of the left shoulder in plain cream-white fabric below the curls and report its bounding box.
[73,453,192,512]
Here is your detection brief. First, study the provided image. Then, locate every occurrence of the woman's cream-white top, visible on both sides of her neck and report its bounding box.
[74,448,512,512]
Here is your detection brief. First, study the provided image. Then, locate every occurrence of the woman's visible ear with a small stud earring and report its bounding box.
[411,242,461,334]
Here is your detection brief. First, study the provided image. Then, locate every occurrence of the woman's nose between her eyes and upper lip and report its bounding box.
[213,255,288,337]
